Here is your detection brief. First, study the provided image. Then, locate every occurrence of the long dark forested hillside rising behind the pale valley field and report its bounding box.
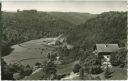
[2,10,94,44]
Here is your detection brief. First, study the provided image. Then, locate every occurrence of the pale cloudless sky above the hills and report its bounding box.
[2,0,127,14]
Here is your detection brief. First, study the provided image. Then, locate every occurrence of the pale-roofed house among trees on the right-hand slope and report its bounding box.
[93,44,120,61]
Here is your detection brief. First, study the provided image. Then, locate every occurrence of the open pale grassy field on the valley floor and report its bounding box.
[4,39,55,66]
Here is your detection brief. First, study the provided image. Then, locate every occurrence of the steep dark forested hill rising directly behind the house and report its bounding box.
[68,12,127,48]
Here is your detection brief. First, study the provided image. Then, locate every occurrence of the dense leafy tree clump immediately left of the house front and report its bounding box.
[80,50,103,74]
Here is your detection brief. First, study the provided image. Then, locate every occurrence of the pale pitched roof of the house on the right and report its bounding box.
[96,44,119,52]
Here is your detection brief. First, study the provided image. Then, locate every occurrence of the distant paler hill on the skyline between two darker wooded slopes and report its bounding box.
[48,12,96,25]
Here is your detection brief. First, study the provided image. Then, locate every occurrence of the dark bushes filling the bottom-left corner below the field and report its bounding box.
[1,59,32,80]
